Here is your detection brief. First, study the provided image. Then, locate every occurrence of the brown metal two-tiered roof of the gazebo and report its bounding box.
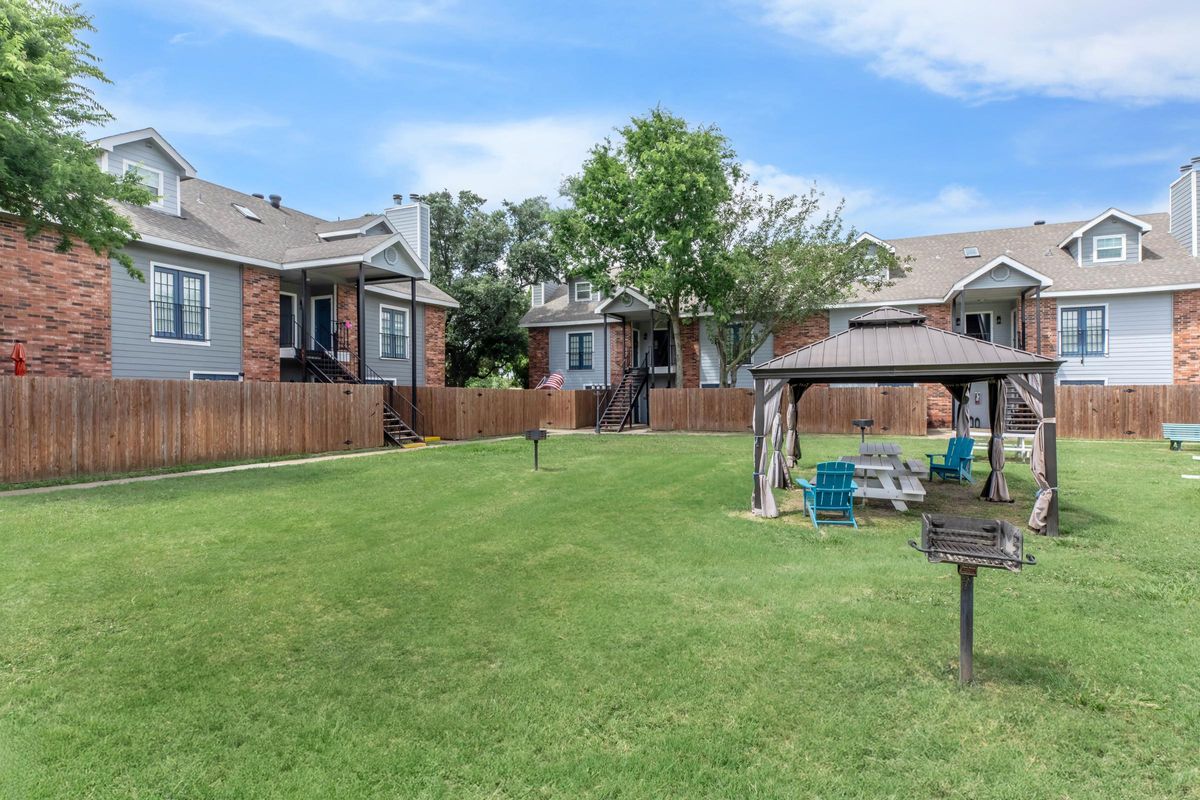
[750,308,1062,383]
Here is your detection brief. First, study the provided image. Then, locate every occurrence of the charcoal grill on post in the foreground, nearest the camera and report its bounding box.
[908,513,1037,685]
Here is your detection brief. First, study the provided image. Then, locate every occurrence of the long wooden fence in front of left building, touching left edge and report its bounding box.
[0,377,384,482]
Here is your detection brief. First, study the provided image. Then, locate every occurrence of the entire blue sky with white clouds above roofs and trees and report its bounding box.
[85,0,1200,237]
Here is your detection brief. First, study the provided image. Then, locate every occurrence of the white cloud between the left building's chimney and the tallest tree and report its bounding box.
[377,116,613,204]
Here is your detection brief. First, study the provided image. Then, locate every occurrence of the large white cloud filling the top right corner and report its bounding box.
[755,0,1200,102]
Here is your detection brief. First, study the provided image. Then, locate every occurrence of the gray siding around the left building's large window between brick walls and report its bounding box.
[113,245,241,379]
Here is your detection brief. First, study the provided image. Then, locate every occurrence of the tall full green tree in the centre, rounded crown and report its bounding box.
[557,108,740,374]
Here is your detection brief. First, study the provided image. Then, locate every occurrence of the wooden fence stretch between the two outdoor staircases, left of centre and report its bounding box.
[410,386,595,439]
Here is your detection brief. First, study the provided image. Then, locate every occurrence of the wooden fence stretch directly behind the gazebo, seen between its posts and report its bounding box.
[650,386,925,437]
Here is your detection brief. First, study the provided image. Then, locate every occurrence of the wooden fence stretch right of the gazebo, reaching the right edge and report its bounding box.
[1056,384,1200,439]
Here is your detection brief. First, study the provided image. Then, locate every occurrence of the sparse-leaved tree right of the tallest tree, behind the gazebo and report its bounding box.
[706,179,904,386]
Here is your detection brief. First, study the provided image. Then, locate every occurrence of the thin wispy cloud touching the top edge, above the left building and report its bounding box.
[168,0,456,66]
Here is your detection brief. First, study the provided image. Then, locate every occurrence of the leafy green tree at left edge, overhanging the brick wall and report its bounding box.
[0,0,151,277]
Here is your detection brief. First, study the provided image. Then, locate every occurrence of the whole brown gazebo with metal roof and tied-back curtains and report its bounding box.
[750,308,1062,536]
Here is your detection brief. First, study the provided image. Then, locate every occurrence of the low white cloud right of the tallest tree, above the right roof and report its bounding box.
[745,161,1108,239]
